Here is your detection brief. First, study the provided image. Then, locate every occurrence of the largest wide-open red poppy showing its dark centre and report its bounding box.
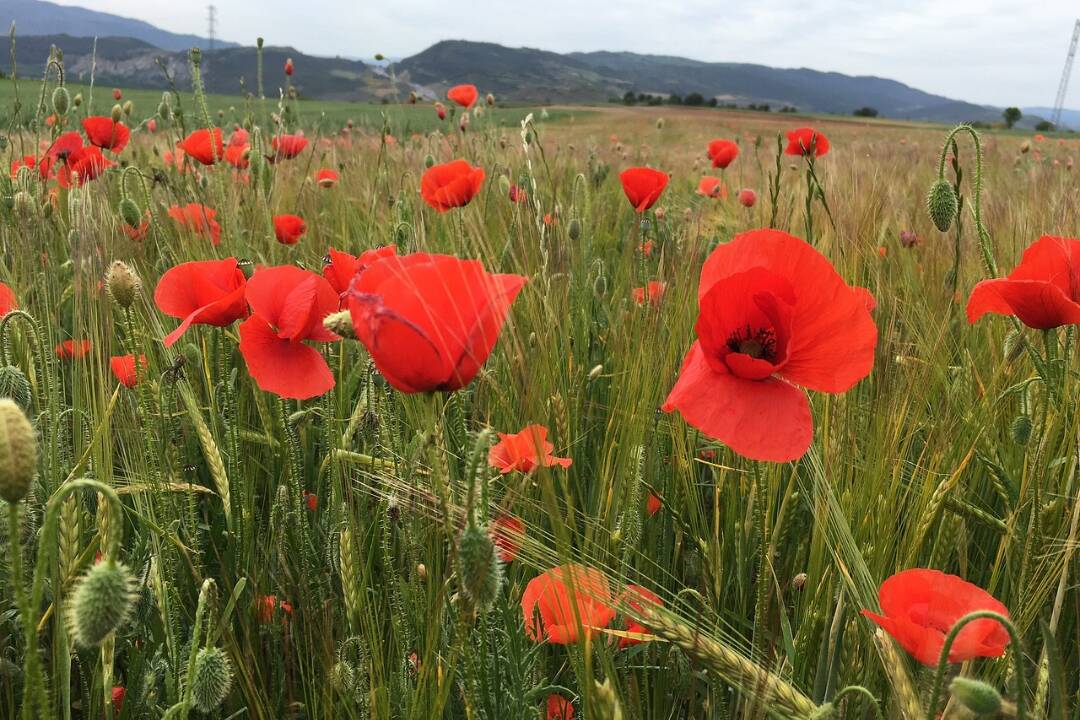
[663,230,877,462]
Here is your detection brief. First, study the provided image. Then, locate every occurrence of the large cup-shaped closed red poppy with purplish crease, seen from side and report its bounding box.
[349,253,526,393]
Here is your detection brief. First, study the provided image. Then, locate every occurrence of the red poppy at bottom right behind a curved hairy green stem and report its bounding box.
[863,568,1009,666]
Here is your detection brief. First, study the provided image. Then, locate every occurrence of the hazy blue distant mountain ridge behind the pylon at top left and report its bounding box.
[0,0,237,51]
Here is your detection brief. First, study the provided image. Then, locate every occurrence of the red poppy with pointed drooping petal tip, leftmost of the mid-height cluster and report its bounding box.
[153,258,247,348]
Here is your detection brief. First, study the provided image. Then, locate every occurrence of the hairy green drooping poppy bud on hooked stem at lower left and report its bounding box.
[68,560,136,648]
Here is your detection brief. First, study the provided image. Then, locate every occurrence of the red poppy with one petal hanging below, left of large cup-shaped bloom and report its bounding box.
[240,266,339,399]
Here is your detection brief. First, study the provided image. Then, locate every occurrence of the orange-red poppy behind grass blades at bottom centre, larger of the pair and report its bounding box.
[522,563,616,644]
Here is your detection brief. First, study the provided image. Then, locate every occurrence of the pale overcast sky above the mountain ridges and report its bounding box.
[53,0,1080,109]
